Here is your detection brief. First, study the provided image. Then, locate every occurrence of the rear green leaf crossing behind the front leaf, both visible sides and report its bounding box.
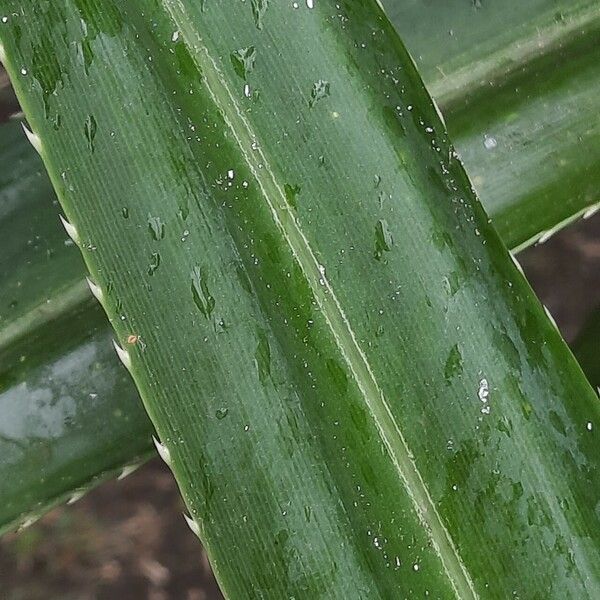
[0,0,600,531]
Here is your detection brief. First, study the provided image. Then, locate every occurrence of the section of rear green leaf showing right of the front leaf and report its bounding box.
[384,0,600,249]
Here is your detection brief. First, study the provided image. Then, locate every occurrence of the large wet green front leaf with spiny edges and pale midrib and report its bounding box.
[0,0,599,598]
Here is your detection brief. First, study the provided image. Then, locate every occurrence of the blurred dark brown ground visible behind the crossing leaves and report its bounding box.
[0,42,600,600]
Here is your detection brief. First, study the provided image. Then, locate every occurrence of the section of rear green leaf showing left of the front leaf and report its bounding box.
[0,122,151,532]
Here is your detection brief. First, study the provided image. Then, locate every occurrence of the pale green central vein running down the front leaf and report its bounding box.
[163,0,478,599]
